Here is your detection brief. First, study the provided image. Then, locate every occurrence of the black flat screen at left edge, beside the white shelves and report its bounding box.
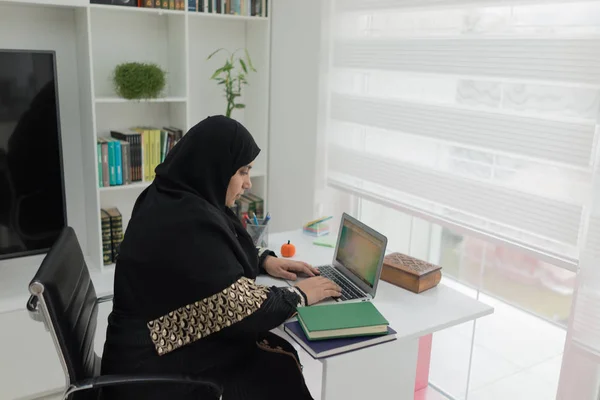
[0,49,67,259]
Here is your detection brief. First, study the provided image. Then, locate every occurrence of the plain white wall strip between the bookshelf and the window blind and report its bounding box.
[268,0,321,232]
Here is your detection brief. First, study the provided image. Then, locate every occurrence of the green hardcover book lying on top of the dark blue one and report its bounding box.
[298,301,389,340]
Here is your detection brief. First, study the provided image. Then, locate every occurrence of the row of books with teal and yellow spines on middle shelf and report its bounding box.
[97,127,183,187]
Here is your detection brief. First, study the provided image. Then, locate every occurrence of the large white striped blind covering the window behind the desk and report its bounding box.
[323,0,600,270]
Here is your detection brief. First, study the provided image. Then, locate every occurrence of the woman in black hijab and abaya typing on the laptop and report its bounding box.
[102,116,340,400]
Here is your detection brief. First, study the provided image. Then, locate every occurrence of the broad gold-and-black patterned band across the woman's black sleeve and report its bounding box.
[147,277,269,355]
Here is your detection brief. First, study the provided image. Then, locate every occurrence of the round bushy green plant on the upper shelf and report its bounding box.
[113,62,166,99]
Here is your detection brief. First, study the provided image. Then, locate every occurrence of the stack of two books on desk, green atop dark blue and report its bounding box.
[284,301,396,359]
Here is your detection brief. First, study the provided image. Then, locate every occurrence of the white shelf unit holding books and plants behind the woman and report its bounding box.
[0,0,270,272]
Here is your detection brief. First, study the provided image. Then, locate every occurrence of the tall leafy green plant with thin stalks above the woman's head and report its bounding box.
[207,49,256,117]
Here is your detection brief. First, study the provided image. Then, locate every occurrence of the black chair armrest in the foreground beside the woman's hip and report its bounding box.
[64,374,223,399]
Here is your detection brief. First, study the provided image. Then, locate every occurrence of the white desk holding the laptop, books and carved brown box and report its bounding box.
[258,230,493,400]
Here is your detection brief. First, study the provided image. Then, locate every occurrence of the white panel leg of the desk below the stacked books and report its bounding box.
[321,338,419,400]
